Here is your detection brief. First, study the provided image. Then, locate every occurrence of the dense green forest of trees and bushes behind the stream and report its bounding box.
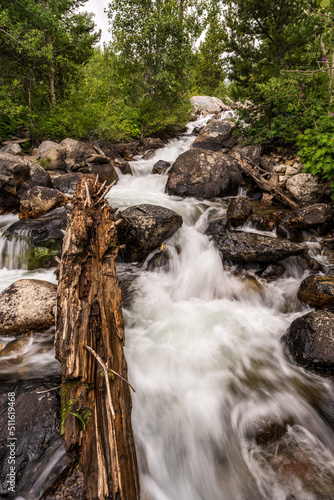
[0,0,334,177]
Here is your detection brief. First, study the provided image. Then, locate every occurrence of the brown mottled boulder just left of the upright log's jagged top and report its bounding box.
[20,186,68,219]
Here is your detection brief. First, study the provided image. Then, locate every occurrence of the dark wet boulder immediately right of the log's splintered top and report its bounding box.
[117,204,182,262]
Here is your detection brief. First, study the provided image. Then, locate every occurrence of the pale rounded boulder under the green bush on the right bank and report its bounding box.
[286,174,321,205]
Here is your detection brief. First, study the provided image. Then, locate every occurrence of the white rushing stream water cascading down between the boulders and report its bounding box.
[0,115,334,500]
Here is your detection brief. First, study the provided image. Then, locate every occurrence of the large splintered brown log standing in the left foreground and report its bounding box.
[55,175,140,500]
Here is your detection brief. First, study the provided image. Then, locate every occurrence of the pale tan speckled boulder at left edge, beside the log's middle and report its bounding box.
[0,279,57,335]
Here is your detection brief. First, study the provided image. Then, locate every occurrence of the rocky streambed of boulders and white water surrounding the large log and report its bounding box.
[0,99,334,500]
